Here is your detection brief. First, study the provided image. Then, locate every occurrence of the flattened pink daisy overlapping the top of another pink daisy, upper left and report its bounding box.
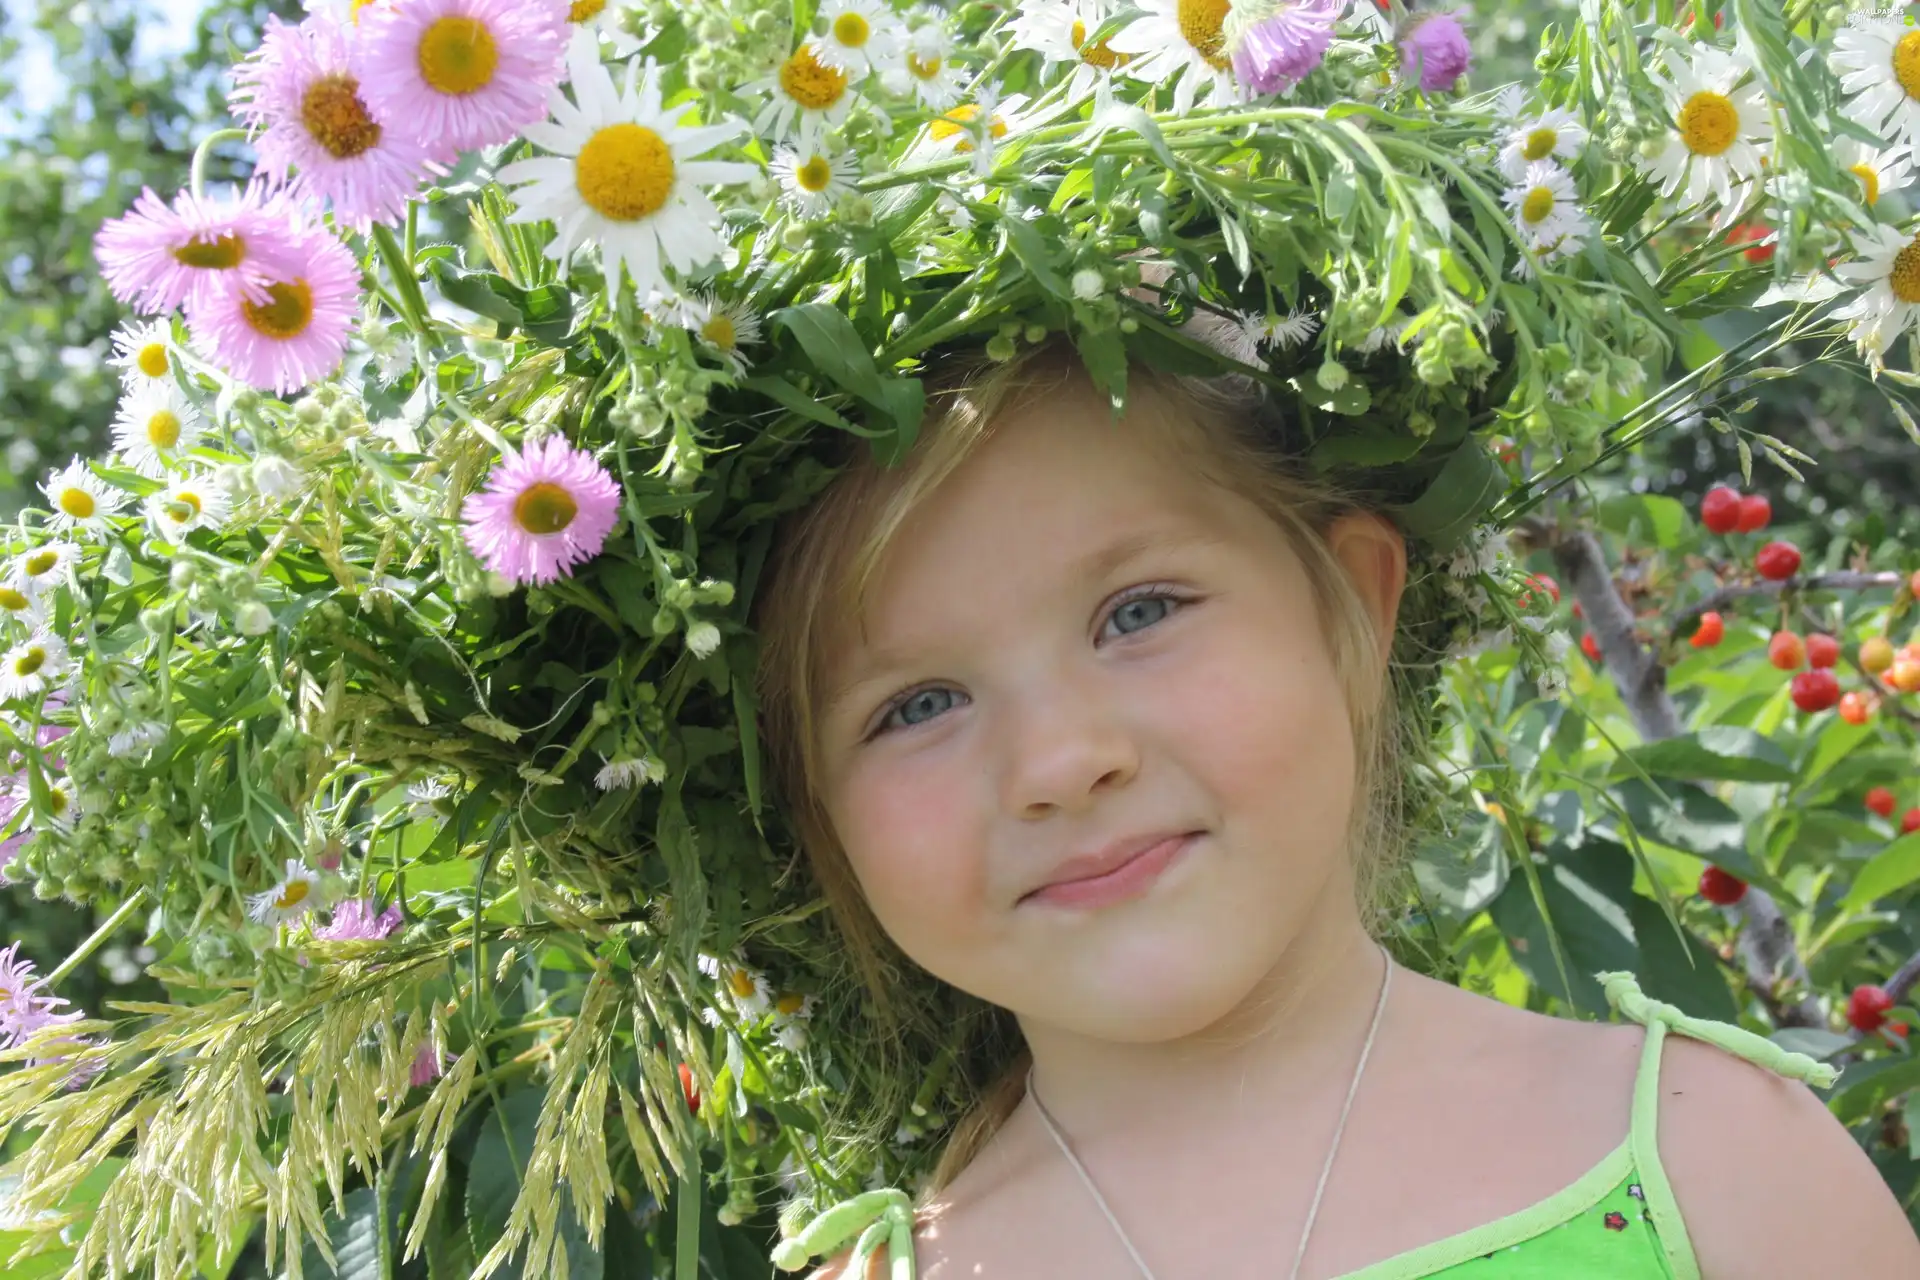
[94,182,300,315]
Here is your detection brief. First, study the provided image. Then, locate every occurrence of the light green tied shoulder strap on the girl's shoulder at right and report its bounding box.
[1594,973,1839,1280]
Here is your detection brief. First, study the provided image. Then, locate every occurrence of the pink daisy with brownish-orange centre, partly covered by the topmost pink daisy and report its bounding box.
[230,13,445,232]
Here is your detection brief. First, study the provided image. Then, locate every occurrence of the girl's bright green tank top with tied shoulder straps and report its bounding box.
[774,973,1839,1280]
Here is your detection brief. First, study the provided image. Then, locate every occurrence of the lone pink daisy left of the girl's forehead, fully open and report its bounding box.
[461,436,620,585]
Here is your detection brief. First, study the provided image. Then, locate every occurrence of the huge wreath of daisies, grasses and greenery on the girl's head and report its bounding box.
[0,0,1920,1276]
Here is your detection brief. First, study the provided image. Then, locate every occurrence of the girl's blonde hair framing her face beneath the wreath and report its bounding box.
[753,340,1409,1194]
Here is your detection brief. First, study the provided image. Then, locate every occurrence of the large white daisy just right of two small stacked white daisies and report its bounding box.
[1638,48,1774,207]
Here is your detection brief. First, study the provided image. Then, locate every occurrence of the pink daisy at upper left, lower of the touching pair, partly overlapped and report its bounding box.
[186,226,361,395]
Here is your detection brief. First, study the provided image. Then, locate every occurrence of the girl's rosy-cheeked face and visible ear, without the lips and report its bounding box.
[822,380,1405,1042]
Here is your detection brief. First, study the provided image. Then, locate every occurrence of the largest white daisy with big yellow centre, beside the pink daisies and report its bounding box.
[495,36,758,296]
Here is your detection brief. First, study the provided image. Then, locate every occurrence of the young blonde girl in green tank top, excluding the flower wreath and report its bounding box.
[758,345,1920,1280]
